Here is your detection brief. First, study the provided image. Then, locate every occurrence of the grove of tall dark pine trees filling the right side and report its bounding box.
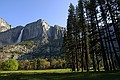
[62,0,120,72]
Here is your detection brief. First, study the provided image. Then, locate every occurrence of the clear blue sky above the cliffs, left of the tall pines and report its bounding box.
[0,0,78,27]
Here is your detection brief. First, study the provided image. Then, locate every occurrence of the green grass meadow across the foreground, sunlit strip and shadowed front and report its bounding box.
[0,69,120,80]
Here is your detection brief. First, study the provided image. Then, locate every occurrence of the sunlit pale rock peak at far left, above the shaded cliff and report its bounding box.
[0,18,11,32]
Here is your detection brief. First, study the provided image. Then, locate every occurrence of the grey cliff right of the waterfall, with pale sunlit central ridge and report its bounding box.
[22,19,65,57]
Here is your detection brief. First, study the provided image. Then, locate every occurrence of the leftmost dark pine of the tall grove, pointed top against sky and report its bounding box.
[67,4,76,71]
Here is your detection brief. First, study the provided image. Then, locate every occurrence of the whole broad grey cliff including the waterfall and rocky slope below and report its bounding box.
[0,19,65,59]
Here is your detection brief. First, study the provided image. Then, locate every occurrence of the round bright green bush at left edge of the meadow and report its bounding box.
[3,59,18,71]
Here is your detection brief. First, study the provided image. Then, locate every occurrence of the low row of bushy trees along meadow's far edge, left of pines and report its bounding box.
[0,58,66,71]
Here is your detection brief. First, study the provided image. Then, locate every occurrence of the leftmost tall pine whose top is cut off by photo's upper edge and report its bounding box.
[78,0,90,72]
